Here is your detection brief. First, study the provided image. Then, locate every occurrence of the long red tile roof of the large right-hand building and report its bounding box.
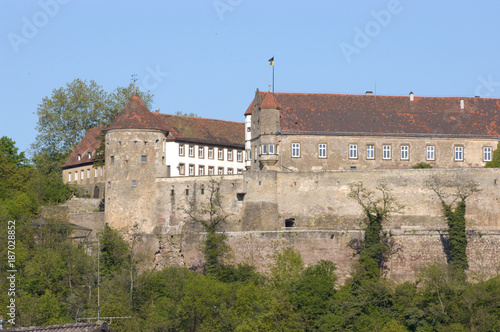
[245,93,500,138]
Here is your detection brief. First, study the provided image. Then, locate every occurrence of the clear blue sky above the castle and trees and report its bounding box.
[0,0,500,151]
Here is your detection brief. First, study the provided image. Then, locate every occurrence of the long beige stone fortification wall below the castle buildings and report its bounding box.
[119,169,500,280]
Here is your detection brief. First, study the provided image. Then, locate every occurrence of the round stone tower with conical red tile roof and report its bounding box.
[105,95,168,234]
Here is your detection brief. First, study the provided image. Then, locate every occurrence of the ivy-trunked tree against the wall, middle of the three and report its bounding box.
[349,183,404,278]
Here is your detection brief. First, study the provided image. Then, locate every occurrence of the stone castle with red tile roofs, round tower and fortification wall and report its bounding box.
[63,90,500,279]
